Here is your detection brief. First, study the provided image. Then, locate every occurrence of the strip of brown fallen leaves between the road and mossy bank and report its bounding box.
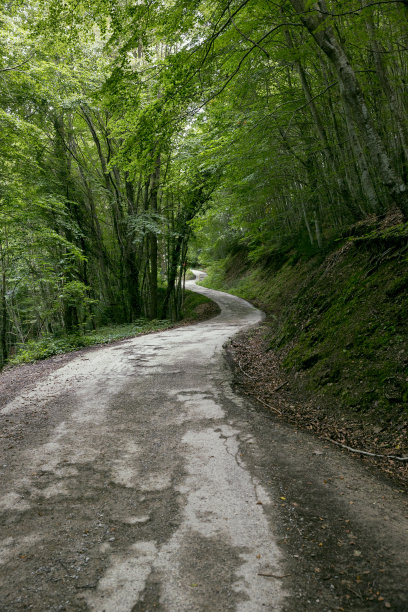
[224,324,408,489]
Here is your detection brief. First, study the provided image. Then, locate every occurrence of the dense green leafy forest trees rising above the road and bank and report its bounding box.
[0,0,408,366]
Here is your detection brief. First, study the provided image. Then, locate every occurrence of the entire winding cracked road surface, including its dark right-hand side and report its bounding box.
[0,274,408,612]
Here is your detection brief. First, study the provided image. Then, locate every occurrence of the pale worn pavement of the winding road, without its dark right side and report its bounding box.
[0,272,284,612]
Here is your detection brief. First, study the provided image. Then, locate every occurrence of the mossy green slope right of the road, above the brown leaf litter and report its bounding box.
[205,227,408,424]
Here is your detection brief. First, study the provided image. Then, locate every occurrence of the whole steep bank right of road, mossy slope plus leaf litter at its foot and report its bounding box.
[202,221,408,486]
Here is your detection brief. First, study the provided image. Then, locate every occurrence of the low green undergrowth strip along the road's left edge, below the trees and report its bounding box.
[8,291,213,365]
